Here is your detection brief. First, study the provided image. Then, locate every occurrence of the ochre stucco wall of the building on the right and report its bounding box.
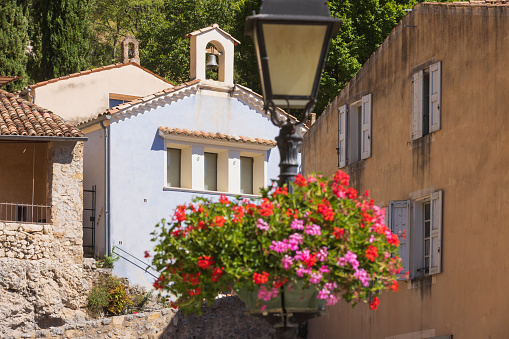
[304,3,509,339]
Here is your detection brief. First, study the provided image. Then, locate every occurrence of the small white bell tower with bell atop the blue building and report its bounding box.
[186,24,240,86]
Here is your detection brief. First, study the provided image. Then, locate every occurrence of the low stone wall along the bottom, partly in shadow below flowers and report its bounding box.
[5,296,276,339]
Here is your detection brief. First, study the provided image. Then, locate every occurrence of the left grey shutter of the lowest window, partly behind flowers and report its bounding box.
[387,200,410,280]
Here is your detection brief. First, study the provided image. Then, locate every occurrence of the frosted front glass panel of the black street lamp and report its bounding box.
[263,23,327,96]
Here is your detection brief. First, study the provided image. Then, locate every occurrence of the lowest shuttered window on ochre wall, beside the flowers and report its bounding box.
[388,191,442,280]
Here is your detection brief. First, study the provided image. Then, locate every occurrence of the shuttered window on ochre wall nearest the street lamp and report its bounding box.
[337,94,372,168]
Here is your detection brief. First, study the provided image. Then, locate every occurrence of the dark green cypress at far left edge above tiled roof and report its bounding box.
[0,0,28,91]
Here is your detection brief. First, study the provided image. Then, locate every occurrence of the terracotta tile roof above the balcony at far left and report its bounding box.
[0,89,84,138]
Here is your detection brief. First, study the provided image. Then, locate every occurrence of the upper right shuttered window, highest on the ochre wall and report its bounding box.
[412,61,441,140]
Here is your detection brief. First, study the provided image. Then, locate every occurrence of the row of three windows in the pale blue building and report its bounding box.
[162,134,274,195]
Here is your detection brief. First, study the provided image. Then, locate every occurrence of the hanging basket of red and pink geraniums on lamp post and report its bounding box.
[147,171,405,314]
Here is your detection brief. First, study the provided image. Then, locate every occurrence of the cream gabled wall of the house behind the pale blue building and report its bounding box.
[31,64,173,121]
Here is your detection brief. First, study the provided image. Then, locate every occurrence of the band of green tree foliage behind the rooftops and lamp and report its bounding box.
[0,0,450,114]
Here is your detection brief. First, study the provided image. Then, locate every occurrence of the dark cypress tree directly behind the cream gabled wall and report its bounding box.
[30,0,91,81]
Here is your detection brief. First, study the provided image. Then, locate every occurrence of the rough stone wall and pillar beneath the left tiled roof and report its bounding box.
[0,142,93,338]
